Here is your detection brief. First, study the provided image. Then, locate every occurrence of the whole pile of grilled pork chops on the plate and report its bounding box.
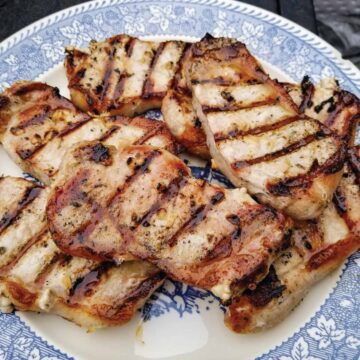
[0,35,360,333]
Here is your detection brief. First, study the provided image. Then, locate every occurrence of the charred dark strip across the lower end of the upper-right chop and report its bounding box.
[267,143,346,196]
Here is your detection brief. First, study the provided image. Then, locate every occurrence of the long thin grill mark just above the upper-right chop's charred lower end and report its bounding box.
[231,130,326,169]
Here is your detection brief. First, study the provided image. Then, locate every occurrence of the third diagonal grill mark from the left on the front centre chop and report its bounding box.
[168,191,225,247]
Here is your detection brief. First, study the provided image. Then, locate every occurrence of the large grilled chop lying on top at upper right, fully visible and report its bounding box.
[187,37,346,219]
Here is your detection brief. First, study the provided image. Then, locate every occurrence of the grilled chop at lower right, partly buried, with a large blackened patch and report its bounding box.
[225,147,360,333]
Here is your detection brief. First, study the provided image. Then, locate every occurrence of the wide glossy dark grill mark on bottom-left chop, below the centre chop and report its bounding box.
[69,262,114,304]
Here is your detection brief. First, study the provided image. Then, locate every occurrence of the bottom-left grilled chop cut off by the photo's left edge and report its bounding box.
[0,177,164,328]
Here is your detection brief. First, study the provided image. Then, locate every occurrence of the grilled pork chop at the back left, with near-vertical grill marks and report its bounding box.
[65,35,186,116]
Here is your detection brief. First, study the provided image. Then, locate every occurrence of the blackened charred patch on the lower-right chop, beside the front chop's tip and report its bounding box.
[242,266,286,308]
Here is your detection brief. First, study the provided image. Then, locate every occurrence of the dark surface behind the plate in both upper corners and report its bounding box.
[0,0,360,66]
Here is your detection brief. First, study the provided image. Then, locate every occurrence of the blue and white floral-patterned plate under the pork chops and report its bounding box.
[0,0,360,360]
